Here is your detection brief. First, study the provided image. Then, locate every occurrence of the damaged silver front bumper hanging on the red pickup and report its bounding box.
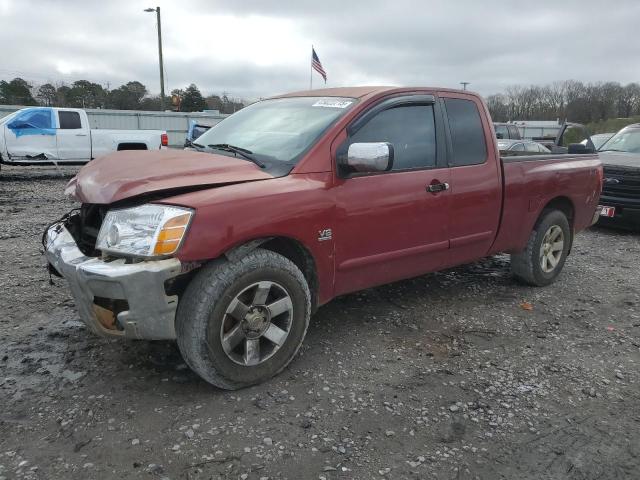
[45,223,183,340]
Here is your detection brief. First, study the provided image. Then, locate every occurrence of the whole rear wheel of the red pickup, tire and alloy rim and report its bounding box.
[511,210,572,287]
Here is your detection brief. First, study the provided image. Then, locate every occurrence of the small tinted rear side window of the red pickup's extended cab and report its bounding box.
[444,98,487,167]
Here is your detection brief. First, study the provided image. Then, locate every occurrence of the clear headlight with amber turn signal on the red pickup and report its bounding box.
[96,204,193,257]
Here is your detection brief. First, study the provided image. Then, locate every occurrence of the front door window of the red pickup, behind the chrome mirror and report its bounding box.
[349,105,436,170]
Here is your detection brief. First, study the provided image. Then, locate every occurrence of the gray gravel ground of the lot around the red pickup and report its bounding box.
[0,166,640,480]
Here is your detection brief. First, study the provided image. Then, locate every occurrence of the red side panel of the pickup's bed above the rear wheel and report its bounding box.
[491,154,601,253]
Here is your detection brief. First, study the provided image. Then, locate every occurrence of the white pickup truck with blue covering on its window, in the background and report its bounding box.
[0,107,168,169]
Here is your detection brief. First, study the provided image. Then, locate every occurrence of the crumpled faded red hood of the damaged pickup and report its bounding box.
[65,150,274,204]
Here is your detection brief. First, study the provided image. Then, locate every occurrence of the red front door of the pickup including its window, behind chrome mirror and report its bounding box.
[333,95,450,295]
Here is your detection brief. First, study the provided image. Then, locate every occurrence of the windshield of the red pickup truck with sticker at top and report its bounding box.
[197,97,356,163]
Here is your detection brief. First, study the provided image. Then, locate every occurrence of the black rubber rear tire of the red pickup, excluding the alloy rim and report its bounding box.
[511,210,573,287]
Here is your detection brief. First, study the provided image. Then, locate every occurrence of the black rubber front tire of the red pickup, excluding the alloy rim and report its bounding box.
[176,249,311,390]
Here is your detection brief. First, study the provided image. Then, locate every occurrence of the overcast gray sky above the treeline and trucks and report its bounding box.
[0,0,640,99]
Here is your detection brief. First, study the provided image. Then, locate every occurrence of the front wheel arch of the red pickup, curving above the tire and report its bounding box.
[224,236,319,312]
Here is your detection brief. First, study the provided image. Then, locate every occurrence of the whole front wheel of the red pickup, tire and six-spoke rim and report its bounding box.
[176,249,311,390]
